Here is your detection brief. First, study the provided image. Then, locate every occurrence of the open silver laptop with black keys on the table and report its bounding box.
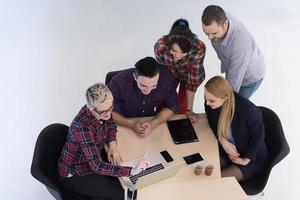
[121,152,184,191]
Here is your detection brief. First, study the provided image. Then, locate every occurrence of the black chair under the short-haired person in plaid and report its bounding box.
[31,124,89,200]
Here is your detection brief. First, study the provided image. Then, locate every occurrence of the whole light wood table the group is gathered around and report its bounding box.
[117,114,245,200]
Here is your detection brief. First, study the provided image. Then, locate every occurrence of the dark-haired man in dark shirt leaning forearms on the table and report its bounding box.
[108,57,178,137]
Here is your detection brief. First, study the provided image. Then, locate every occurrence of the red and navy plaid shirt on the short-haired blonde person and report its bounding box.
[58,105,131,177]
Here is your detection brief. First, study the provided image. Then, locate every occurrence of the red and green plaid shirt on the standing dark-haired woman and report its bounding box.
[154,36,205,92]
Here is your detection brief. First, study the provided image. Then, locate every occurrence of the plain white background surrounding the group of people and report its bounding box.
[0,0,300,200]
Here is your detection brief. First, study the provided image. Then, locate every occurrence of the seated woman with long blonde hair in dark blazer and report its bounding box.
[204,76,268,181]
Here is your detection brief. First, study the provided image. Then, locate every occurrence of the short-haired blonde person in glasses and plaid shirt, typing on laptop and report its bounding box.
[58,83,149,200]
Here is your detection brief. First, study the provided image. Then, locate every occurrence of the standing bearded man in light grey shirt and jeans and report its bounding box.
[202,5,266,99]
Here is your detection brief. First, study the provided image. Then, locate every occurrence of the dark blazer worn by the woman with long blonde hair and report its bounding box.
[205,93,267,161]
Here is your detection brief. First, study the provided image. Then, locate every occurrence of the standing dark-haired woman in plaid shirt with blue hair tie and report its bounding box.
[154,19,205,122]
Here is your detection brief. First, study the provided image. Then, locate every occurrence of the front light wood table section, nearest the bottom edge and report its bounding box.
[137,177,247,200]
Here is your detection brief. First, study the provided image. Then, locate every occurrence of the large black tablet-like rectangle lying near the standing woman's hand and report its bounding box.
[167,119,198,144]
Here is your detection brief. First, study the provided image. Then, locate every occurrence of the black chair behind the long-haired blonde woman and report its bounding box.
[240,107,290,195]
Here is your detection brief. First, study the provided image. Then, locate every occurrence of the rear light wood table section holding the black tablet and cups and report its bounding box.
[117,114,221,182]
